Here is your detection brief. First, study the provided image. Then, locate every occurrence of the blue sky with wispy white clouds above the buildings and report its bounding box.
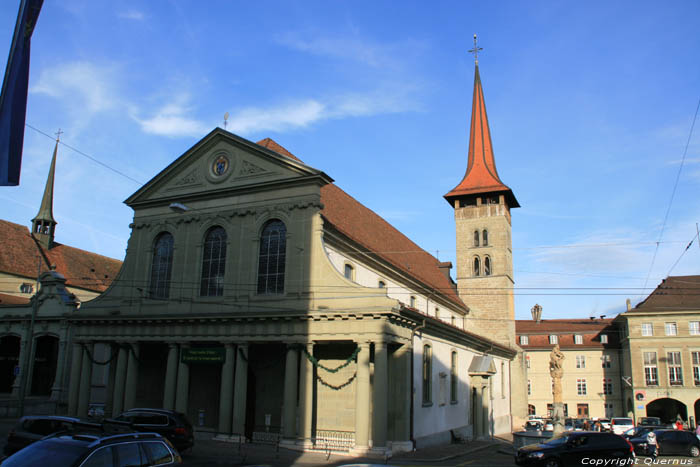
[0,0,700,319]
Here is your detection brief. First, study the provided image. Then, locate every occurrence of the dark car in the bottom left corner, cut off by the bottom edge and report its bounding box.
[0,433,182,467]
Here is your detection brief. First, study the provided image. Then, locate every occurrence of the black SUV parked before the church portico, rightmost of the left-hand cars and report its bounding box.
[112,408,194,452]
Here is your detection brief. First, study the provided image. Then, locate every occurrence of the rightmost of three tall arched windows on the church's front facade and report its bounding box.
[258,219,287,294]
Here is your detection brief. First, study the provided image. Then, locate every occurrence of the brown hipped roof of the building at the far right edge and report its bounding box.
[626,276,700,313]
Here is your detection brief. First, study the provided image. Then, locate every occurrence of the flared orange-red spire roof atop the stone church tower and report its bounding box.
[445,63,520,208]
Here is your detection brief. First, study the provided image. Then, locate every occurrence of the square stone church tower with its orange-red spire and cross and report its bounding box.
[445,42,520,345]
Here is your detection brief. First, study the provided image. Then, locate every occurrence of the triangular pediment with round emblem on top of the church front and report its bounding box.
[125,128,332,207]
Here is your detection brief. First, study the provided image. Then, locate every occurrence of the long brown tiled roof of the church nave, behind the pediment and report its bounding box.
[257,138,465,308]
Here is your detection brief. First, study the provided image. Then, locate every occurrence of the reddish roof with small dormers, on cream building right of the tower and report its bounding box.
[515,318,619,348]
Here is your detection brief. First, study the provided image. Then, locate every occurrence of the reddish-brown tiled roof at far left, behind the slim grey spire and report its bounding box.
[0,220,122,292]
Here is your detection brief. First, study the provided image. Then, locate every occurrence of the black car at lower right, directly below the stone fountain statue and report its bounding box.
[515,431,634,467]
